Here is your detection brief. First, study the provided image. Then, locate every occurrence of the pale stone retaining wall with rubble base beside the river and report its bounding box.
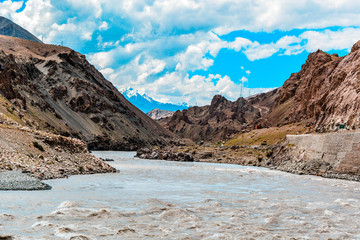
[268,131,360,181]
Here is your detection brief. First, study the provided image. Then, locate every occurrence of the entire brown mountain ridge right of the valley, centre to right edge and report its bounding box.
[162,41,360,140]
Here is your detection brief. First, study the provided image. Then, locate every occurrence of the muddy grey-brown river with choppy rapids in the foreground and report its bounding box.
[0,152,360,239]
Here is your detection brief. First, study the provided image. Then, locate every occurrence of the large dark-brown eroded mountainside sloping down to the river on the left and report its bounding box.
[0,36,174,150]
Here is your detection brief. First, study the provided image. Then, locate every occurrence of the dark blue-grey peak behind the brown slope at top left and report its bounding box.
[0,16,41,42]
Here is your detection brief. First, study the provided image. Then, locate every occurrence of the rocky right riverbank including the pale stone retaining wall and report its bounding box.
[136,132,360,181]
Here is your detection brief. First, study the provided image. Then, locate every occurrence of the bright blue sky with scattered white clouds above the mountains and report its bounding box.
[0,0,360,105]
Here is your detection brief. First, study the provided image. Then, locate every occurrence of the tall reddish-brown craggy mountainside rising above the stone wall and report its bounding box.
[267,42,360,132]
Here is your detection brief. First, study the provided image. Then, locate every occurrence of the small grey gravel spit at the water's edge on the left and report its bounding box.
[0,171,51,191]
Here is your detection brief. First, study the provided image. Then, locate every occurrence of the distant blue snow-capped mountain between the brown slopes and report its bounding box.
[120,88,190,113]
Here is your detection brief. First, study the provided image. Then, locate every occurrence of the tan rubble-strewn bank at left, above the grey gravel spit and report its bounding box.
[0,124,116,180]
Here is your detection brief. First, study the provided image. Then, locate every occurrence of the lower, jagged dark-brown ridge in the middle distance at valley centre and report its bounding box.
[162,95,261,141]
